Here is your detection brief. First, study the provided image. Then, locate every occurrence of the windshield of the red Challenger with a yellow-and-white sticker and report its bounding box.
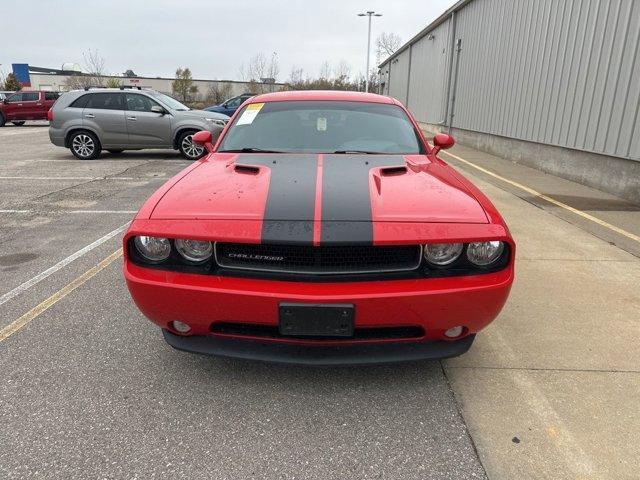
[218,101,424,154]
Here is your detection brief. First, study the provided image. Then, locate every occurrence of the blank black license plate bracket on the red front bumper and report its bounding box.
[279,303,355,337]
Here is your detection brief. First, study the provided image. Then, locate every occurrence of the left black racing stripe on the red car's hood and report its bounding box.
[235,154,318,244]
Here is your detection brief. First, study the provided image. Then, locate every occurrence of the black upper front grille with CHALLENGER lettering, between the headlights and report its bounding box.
[215,243,422,275]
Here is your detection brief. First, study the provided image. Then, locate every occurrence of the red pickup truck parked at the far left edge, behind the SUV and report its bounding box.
[0,91,60,127]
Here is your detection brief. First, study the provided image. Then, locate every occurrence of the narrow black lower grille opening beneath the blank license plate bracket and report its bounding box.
[211,322,425,342]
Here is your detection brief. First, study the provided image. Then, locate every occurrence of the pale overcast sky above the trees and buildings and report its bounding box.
[0,0,455,81]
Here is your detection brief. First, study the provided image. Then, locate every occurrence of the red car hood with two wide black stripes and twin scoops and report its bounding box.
[151,153,488,241]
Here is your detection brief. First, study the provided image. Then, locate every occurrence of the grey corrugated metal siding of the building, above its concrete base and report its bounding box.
[380,0,640,160]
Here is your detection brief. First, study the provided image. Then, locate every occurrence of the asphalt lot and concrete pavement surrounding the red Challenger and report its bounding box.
[0,125,640,479]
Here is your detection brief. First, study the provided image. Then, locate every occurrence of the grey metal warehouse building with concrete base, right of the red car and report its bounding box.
[380,0,640,203]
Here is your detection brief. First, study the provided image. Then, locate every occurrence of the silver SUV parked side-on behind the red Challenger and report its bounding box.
[48,88,229,160]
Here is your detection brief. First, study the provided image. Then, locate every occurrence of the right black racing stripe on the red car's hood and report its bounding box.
[320,154,406,245]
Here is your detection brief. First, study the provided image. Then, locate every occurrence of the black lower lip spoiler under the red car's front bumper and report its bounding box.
[163,330,475,366]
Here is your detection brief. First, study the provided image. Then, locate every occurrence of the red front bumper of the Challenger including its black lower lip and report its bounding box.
[124,259,513,364]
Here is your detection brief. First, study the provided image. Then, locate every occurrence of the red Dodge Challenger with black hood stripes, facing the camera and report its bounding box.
[124,91,515,365]
